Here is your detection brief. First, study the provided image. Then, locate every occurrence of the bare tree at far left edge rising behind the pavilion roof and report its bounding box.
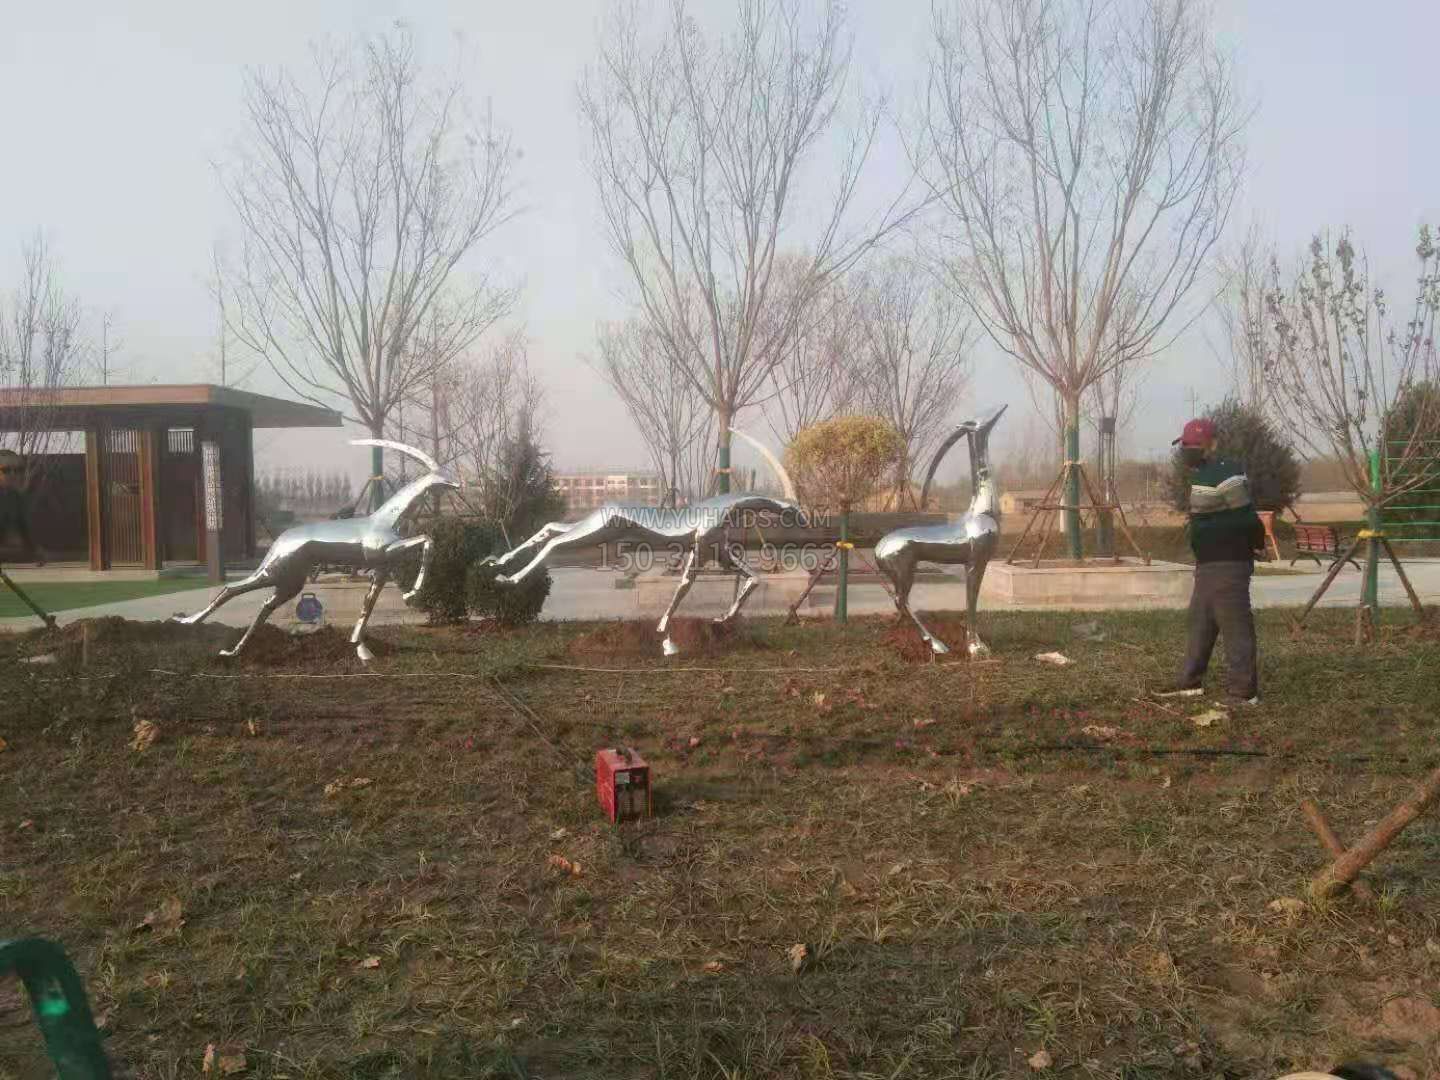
[0,233,89,487]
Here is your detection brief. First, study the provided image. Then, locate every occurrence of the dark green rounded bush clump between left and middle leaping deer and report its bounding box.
[409,517,550,626]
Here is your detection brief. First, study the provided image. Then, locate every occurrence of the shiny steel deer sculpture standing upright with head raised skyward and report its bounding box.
[876,405,1008,657]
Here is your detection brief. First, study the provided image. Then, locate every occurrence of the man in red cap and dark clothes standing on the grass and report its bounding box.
[1158,418,1264,706]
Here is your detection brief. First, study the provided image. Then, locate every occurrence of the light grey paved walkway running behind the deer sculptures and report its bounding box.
[0,560,1440,631]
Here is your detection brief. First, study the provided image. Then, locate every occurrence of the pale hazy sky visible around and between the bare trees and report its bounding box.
[0,0,1440,489]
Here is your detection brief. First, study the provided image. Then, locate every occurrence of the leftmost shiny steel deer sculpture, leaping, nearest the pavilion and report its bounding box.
[177,439,459,662]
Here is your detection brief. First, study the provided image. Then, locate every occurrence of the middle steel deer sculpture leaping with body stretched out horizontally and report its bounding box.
[487,428,802,657]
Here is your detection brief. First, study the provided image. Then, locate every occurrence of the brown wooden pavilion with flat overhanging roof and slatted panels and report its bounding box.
[0,383,341,570]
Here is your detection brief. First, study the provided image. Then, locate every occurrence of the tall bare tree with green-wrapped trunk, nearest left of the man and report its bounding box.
[922,0,1248,557]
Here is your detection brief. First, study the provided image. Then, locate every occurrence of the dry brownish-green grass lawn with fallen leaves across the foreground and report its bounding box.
[0,611,1440,1080]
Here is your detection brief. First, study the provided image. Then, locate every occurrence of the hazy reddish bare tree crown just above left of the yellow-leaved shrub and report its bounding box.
[765,278,863,446]
